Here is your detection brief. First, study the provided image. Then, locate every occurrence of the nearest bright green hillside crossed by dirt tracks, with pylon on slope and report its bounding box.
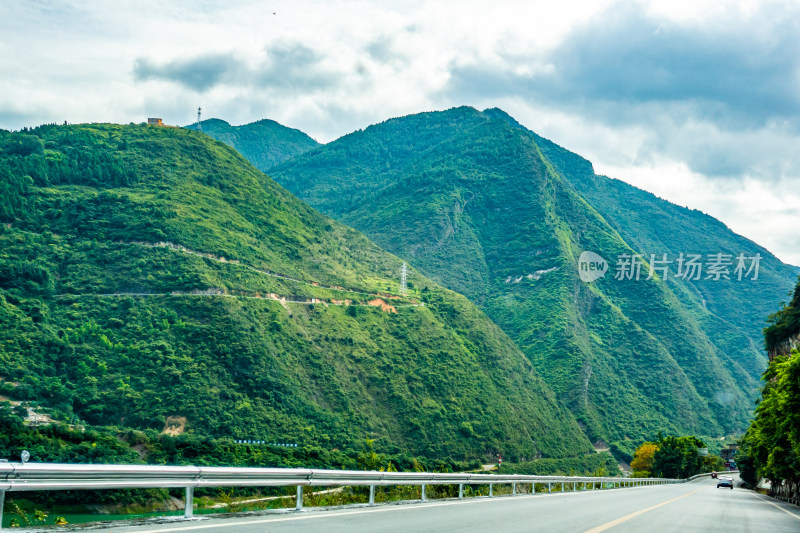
[0,124,592,460]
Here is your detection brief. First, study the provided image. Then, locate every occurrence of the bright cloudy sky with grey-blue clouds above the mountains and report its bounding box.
[0,0,800,265]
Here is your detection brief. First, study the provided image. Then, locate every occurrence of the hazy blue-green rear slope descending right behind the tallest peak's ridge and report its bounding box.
[510,115,797,382]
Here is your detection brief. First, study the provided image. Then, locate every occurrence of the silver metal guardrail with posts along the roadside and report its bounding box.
[0,463,686,518]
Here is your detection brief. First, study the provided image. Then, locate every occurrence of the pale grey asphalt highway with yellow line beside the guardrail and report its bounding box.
[105,478,800,533]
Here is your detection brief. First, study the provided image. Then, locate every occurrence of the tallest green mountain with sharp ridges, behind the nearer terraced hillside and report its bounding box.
[269,108,796,456]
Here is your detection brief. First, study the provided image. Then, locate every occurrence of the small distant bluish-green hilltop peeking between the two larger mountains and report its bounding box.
[186,118,320,169]
